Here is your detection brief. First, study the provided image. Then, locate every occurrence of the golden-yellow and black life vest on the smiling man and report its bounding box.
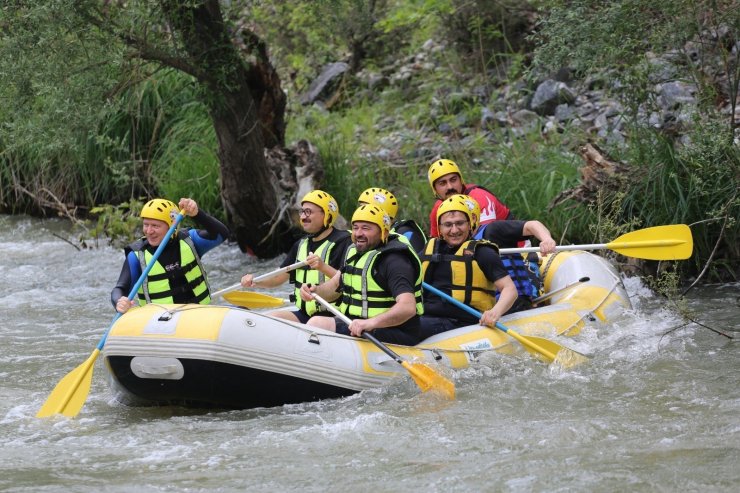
[421,238,498,312]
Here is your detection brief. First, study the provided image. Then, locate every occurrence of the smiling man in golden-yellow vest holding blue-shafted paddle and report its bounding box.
[420,195,517,339]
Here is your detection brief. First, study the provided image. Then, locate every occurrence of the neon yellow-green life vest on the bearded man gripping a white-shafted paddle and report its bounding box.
[339,234,424,319]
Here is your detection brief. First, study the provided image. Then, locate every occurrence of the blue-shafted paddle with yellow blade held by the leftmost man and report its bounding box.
[36,210,185,418]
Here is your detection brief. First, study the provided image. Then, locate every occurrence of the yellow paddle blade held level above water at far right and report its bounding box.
[606,224,694,260]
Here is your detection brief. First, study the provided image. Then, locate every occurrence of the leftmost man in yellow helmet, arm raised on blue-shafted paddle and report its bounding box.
[111,198,229,313]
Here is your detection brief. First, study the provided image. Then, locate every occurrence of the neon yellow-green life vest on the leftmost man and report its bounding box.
[129,231,211,305]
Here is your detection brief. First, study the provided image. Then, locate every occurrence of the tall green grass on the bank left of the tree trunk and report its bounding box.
[0,71,222,226]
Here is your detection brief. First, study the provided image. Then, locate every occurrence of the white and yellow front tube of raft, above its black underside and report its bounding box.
[103,305,405,390]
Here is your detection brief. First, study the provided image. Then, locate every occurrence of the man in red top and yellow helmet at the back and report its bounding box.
[427,159,514,238]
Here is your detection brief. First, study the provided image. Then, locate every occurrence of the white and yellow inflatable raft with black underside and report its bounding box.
[102,251,630,409]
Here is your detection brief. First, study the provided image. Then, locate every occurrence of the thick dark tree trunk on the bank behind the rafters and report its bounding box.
[161,0,314,258]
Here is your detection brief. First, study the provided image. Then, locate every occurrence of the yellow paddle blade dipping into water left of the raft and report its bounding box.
[36,348,100,418]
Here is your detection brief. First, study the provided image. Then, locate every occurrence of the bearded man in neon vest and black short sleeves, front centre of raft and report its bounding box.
[300,204,423,346]
